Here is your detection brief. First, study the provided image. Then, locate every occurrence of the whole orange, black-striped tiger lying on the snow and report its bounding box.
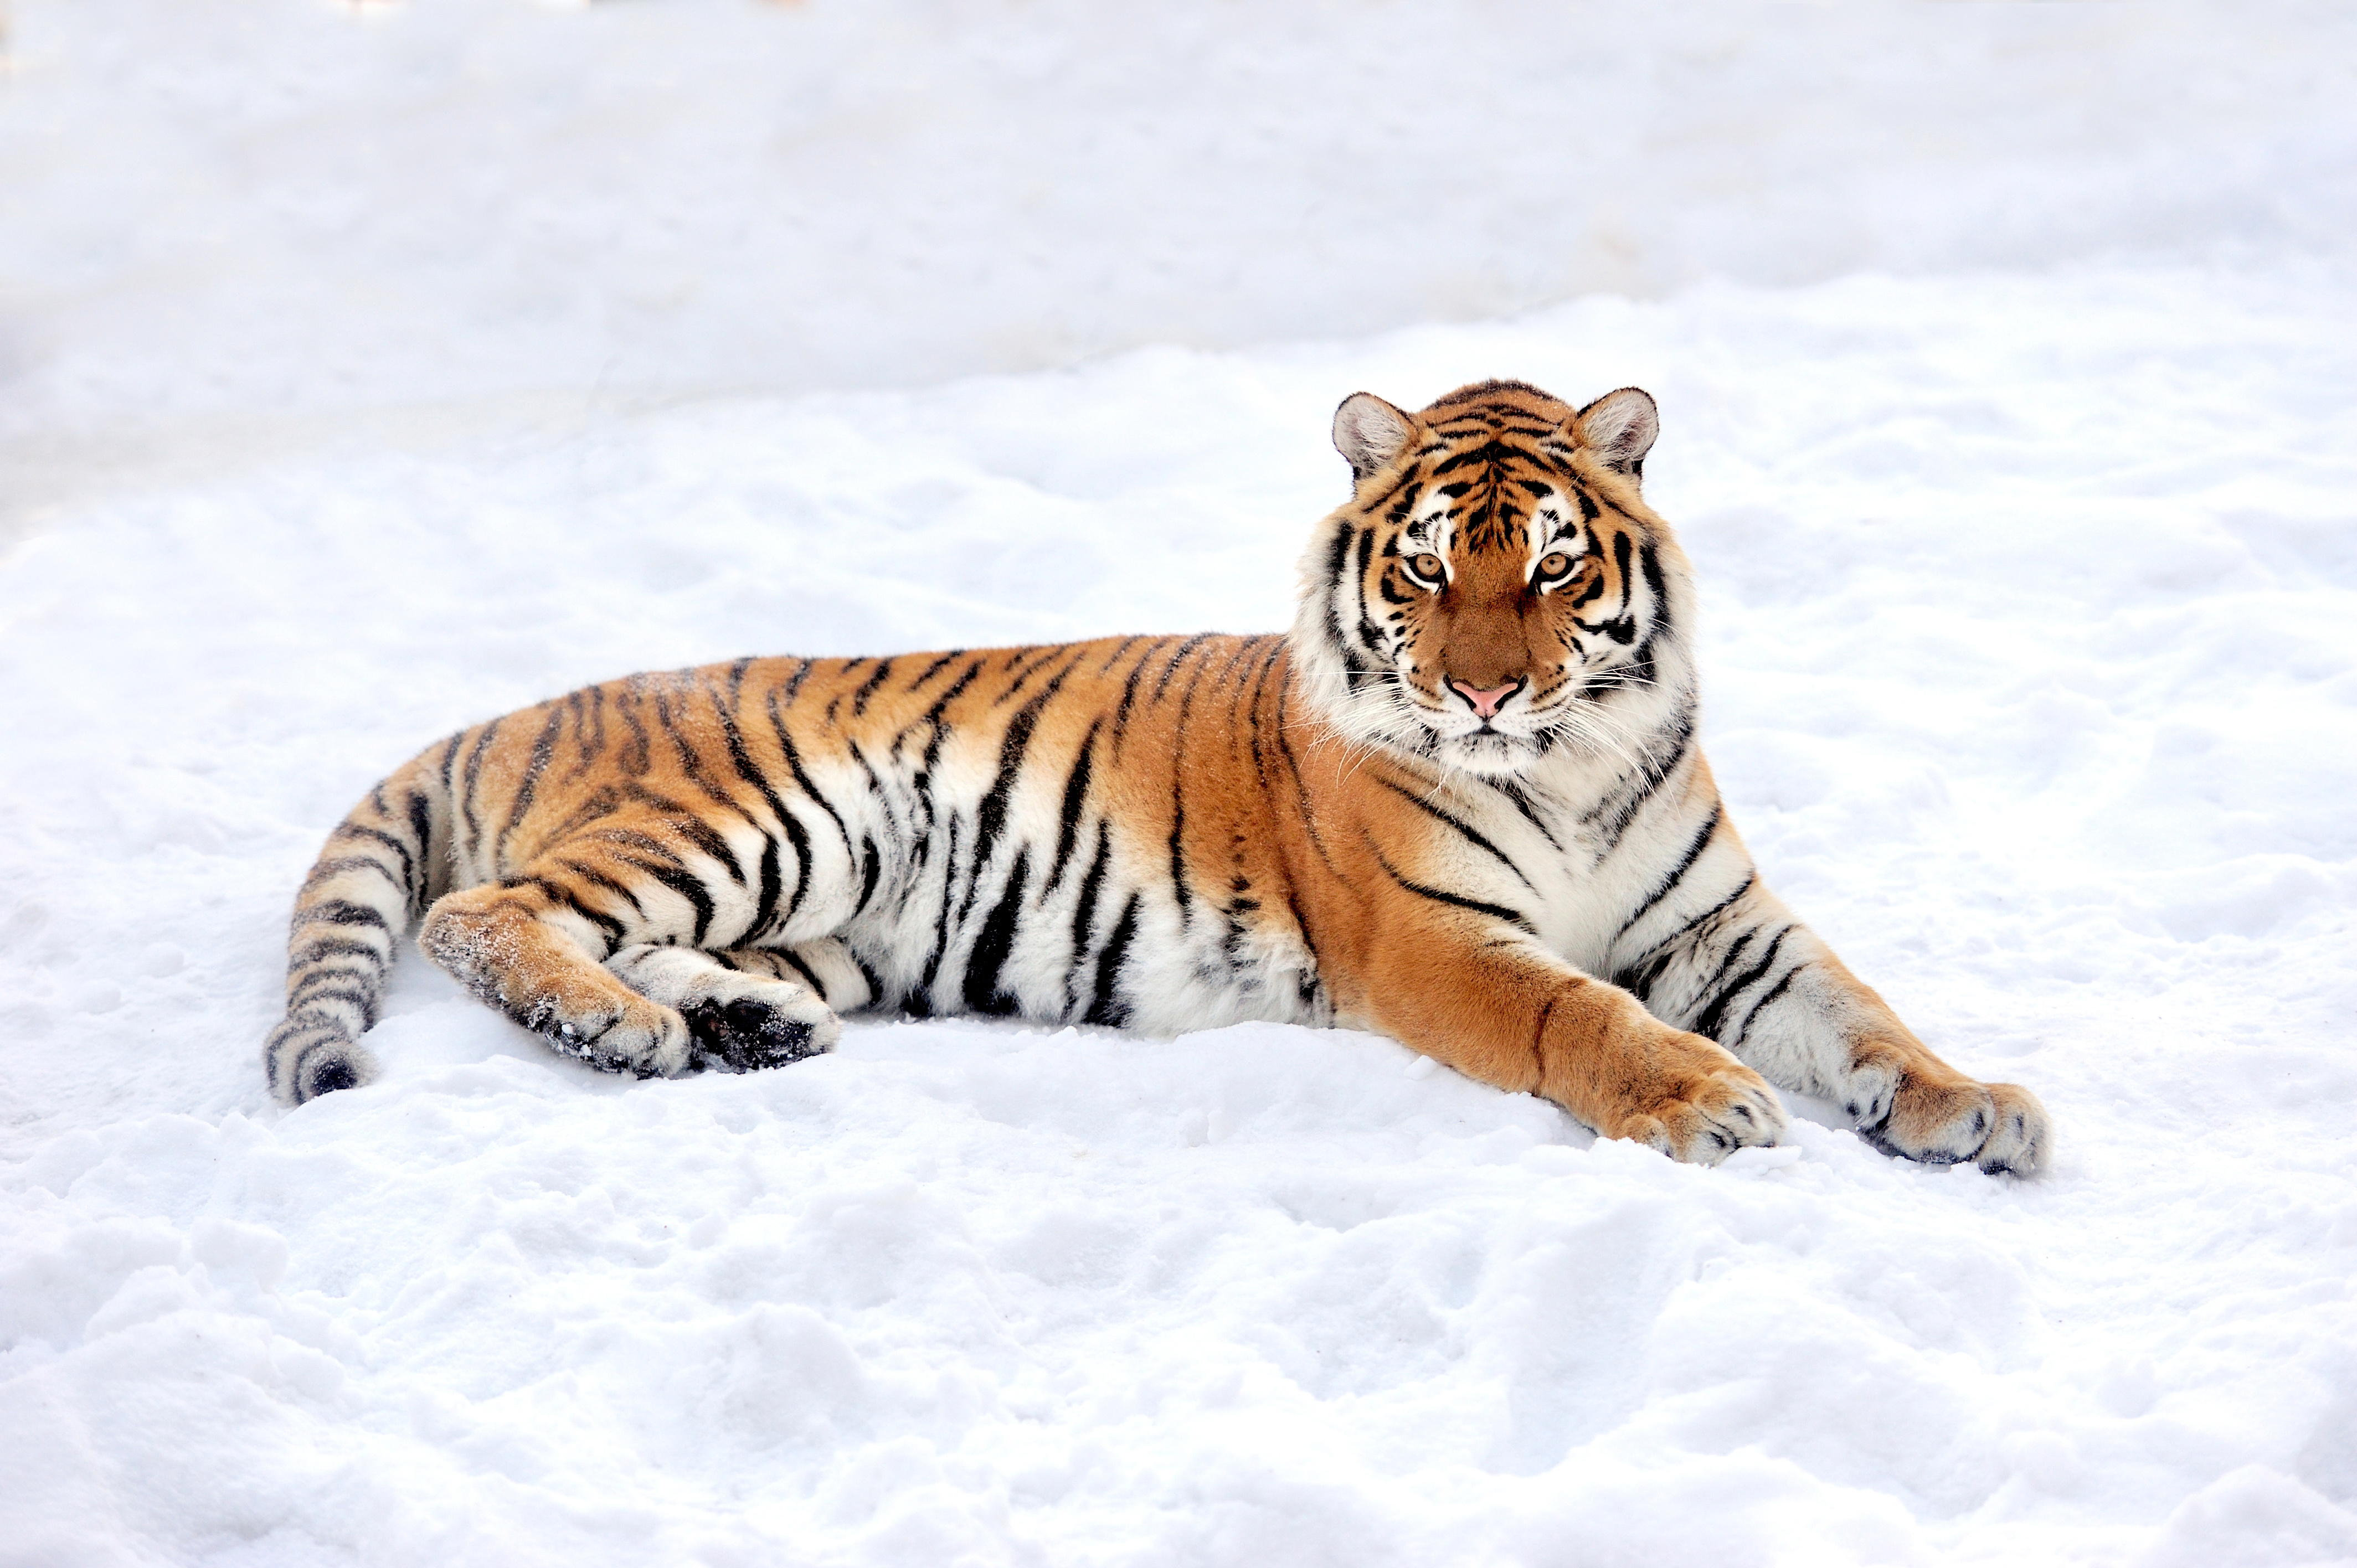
[264,380,2053,1174]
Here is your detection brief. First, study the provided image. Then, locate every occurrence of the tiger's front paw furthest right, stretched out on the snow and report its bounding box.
[1843,1033,2053,1177]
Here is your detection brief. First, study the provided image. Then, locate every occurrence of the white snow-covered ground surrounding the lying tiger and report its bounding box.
[0,0,2357,1568]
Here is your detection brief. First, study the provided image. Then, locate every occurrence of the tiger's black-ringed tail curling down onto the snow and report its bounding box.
[261,747,450,1106]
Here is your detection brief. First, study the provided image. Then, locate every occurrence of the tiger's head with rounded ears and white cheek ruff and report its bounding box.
[1291,382,1692,776]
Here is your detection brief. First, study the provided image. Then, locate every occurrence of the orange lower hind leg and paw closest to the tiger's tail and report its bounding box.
[417,877,696,1077]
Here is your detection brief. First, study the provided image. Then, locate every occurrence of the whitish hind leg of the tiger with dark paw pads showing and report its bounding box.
[606,941,867,1073]
